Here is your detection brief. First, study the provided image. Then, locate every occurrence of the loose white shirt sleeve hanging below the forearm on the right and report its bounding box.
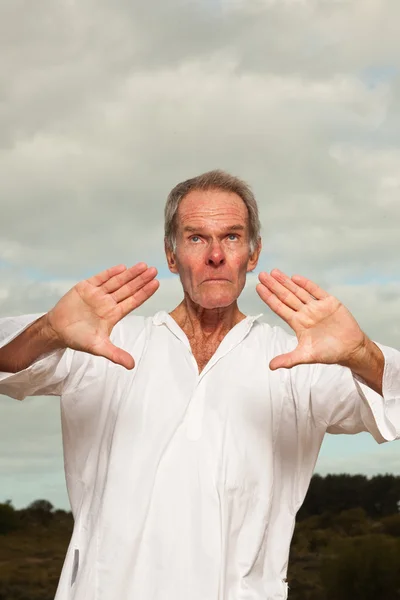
[311,342,400,444]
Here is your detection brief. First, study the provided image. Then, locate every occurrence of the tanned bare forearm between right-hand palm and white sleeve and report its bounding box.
[344,338,385,396]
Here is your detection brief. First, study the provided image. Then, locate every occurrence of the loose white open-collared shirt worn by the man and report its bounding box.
[0,312,400,600]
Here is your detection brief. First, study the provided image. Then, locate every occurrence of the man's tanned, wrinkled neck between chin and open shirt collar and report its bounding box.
[170,294,246,338]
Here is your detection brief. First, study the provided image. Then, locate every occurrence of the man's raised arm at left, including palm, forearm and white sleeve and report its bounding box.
[0,263,159,399]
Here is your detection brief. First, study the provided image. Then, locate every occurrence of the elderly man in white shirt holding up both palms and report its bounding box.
[0,171,400,600]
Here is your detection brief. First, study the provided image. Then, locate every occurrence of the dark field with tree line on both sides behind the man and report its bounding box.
[0,475,400,600]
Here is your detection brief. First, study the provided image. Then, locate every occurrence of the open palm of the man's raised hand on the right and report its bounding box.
[256,269,368,370]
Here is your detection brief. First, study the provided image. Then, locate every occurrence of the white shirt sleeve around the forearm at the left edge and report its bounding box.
[0,313,74,400]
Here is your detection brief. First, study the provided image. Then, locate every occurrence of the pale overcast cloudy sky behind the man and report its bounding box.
[0,0,400,509]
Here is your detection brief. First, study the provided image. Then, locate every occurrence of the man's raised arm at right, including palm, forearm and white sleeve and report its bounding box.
[257,270,400,442]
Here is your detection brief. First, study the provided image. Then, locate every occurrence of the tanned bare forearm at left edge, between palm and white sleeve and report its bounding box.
[0,315,65,373]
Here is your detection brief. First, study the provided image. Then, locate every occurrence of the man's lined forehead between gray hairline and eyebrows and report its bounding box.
[177,190,248,227]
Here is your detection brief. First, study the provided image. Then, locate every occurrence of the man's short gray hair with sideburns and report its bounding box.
[164,169,261,253]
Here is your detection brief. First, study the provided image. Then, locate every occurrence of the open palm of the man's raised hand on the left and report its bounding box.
[46,263,159,369]
